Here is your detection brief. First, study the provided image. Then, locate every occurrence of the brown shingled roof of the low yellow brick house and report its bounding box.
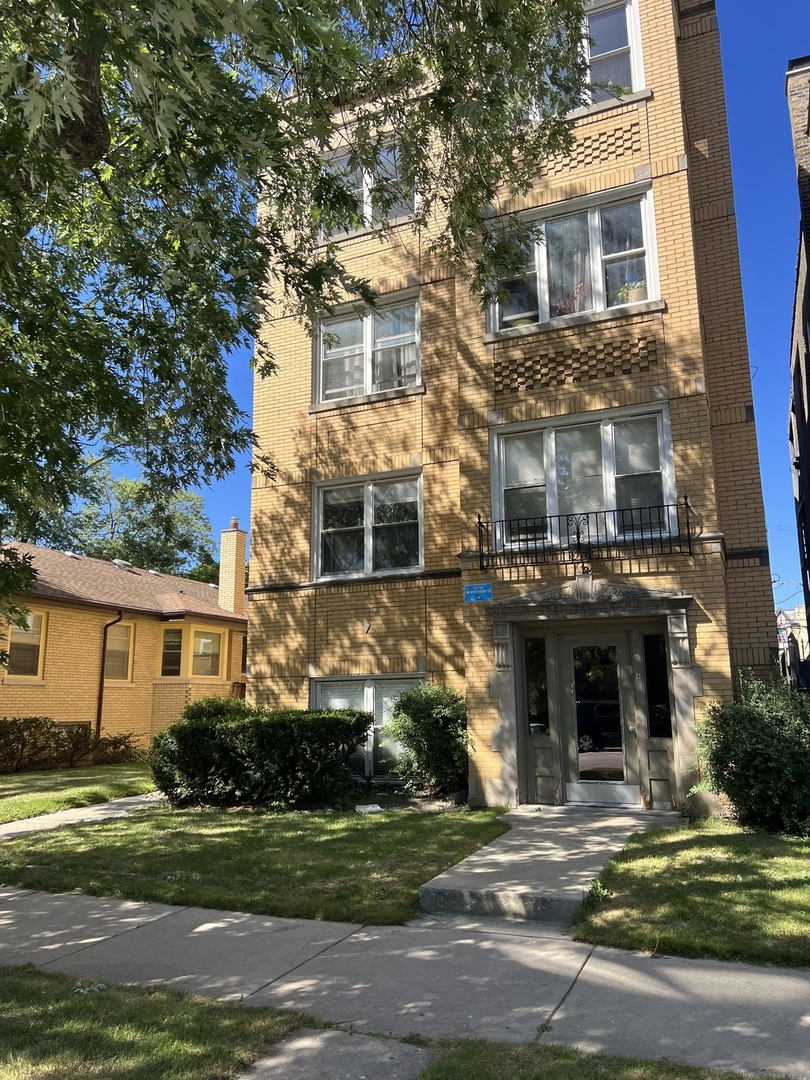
[3,543,247,624]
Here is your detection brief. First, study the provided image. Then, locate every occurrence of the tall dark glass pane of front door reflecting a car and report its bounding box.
[573,645,624,783]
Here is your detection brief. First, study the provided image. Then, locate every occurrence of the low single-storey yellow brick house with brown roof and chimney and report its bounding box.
[0,519,247,745]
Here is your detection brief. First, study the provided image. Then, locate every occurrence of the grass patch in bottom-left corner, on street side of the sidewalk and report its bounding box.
[0,966,306,1080]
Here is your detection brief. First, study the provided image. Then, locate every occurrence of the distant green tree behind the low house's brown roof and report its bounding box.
[15,467,217,581]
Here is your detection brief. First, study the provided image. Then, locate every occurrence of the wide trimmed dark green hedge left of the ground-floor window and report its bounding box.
[151,702,372,809]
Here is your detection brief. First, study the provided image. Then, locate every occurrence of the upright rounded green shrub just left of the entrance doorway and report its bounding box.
[382,683,470,795]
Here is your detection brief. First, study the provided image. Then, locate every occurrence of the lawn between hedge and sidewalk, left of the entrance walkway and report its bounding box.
[0,806,508,924]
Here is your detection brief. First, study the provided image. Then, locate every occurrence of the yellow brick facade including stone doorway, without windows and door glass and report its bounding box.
[248,0,775,806]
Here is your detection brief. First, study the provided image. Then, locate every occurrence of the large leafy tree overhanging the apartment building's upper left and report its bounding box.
[0,0,585,595]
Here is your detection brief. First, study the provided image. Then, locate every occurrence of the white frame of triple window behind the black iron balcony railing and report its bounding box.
[489,404,677,548]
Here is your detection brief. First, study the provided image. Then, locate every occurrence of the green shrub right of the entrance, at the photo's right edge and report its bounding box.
[699,676,810,836]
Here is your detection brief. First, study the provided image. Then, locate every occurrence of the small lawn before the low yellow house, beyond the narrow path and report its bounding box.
[0,765,154,825]
